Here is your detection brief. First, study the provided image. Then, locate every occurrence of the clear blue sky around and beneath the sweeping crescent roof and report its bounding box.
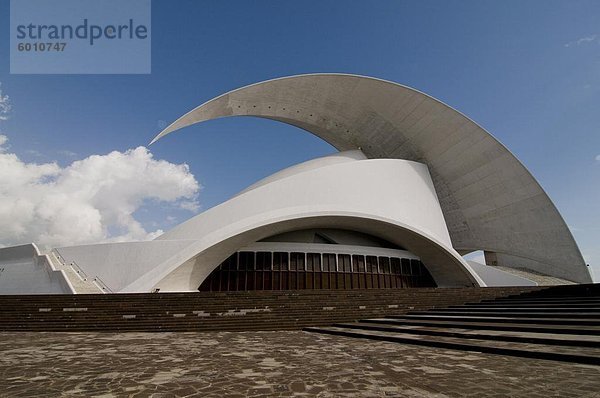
[0,0,600,275]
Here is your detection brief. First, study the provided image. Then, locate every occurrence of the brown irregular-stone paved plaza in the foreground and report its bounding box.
[0,331,600,397]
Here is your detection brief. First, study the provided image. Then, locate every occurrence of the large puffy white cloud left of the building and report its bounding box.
[0,135,200,248]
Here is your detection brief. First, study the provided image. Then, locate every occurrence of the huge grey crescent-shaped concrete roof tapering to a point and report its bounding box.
[152,74,591,282]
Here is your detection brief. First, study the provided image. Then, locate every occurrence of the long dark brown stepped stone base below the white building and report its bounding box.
[0,287,540,332]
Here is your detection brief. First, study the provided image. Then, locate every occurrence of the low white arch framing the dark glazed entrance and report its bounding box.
[127,215,486,292]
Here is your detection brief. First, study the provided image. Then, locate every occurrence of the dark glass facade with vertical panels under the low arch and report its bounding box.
[198,251,436,292]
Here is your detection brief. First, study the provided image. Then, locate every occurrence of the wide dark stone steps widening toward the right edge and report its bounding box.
[304,284,600,365]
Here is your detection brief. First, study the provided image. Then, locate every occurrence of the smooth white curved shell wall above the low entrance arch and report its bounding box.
[157,155,451,246]
